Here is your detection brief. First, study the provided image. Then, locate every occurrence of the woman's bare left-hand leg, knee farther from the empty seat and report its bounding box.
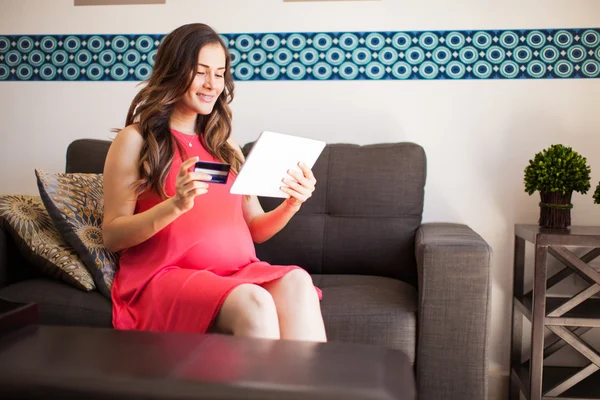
[211,284,280,339]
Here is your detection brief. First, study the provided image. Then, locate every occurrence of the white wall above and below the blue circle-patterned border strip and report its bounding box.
[0,0,600,394]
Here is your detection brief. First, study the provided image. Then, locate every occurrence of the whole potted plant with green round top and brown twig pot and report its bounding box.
[525,144,590,229]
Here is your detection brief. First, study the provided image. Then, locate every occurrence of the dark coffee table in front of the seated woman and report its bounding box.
[0,325,416,400]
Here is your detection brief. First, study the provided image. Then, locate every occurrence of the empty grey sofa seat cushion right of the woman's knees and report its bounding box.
[312,274,418,363]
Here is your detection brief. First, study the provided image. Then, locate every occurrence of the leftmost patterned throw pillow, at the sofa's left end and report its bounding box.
[0,195,96,292]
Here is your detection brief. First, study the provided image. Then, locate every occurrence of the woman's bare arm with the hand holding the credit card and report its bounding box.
[102,125,208,251]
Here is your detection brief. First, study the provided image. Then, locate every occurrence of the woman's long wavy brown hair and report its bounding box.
[126,24,242,199]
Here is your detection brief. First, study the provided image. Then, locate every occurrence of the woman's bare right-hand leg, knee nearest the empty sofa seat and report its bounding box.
[262,269,327,342]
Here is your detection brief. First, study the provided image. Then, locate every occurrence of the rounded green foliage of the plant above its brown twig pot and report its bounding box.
[525,144,600,195]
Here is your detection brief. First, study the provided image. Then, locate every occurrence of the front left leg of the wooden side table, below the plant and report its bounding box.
[529,246,548,400]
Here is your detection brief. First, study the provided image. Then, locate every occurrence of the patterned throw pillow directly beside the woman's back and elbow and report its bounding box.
[35,169,119,298]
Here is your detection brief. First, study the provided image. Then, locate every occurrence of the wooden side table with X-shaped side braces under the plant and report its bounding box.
[510,225,600,400]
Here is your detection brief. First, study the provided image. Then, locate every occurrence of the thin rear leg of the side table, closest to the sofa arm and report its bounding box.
[509,236,525,400]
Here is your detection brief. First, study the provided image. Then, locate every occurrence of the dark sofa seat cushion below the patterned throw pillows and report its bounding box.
[0,278,112,327]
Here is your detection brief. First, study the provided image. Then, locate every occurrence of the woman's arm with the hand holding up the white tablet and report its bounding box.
[229,139,316,243]
